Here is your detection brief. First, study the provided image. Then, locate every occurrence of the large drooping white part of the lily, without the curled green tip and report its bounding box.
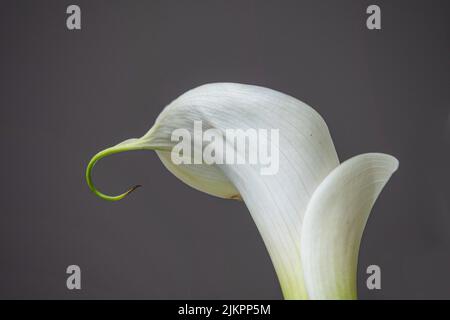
[101,83,339,299]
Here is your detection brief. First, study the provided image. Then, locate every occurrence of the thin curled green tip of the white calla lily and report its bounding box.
[86,146,146,201]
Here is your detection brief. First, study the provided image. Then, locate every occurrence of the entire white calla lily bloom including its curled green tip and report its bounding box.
[86,83,398,299]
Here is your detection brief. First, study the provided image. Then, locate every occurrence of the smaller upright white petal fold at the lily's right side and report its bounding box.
[301,153,398,299]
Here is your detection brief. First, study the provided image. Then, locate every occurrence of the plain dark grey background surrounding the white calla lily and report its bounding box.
[0,0,450,299]
